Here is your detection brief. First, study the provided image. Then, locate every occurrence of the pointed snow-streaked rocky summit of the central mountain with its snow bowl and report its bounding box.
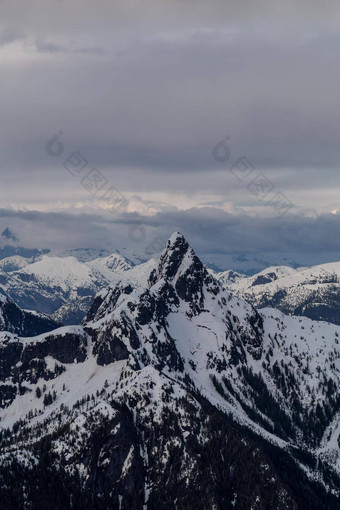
[83,234,262,372]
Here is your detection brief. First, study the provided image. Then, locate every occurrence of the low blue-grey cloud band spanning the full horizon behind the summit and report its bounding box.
[0,208,340,263]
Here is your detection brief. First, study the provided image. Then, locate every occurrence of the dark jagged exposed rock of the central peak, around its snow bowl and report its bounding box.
[84,234,262,370]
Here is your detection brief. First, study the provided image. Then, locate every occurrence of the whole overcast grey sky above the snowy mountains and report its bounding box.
[0,0,340,260]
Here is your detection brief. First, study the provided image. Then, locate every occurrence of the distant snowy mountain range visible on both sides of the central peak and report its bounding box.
[0,237,340,324]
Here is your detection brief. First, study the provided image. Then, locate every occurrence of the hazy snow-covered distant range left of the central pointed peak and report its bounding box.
[0,254,132,324]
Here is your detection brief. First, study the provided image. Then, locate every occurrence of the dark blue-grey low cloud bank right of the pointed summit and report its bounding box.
[135,208,340,254]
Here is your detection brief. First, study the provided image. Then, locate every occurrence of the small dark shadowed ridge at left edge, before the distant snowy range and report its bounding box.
[0,295,60,337]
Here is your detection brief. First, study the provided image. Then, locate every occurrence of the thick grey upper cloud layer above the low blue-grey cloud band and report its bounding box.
[0,0,340,211]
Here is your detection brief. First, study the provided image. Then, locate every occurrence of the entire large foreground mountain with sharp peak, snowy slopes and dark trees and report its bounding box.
[0,233,340,510]
